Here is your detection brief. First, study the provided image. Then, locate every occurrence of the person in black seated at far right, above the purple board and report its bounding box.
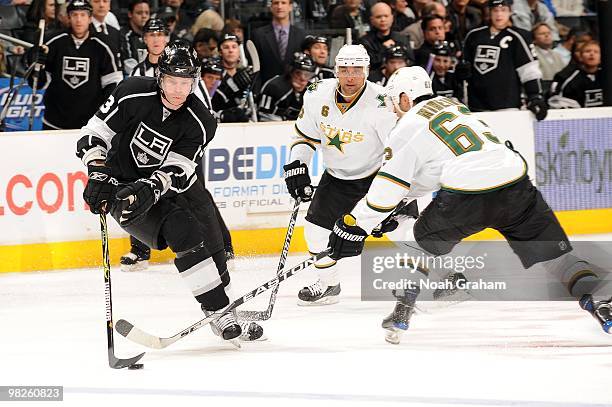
[548,41,603,109]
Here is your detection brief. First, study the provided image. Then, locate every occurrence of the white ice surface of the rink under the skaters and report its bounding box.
[0,255,612,407]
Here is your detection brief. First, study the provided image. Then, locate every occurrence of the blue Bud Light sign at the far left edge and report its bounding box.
[0,78,45,131]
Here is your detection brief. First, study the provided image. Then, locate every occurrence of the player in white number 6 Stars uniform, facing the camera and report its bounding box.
[284,45,395,305]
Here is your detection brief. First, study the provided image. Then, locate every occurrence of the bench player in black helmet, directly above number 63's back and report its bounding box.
[430,42,463,101]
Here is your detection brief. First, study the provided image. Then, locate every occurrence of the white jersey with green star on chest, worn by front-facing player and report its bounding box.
[289,79,396,180]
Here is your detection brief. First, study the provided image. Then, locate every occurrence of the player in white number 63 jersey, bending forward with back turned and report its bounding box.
[329,67,612,343]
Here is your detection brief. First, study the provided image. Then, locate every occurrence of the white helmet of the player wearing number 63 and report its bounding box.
[385,66,433,107]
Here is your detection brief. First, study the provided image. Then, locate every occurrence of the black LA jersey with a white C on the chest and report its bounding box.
[463,27,542,111]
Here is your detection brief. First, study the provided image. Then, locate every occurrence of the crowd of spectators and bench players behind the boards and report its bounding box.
[0,0,603,128]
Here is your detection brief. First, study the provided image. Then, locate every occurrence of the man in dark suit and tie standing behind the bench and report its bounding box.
[252,0,306,83]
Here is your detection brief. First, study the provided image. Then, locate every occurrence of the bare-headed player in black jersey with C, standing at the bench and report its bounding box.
[456,0,548,120]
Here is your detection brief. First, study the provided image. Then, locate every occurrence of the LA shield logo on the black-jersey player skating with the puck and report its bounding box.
[130,123,172,168]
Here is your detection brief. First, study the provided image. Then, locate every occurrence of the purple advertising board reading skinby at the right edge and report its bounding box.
[535,118,612,211]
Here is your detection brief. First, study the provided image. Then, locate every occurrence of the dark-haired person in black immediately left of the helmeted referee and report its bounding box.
[121,0,151,75]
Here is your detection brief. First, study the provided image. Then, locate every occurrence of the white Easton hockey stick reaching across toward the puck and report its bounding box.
[116,249,329,349]
